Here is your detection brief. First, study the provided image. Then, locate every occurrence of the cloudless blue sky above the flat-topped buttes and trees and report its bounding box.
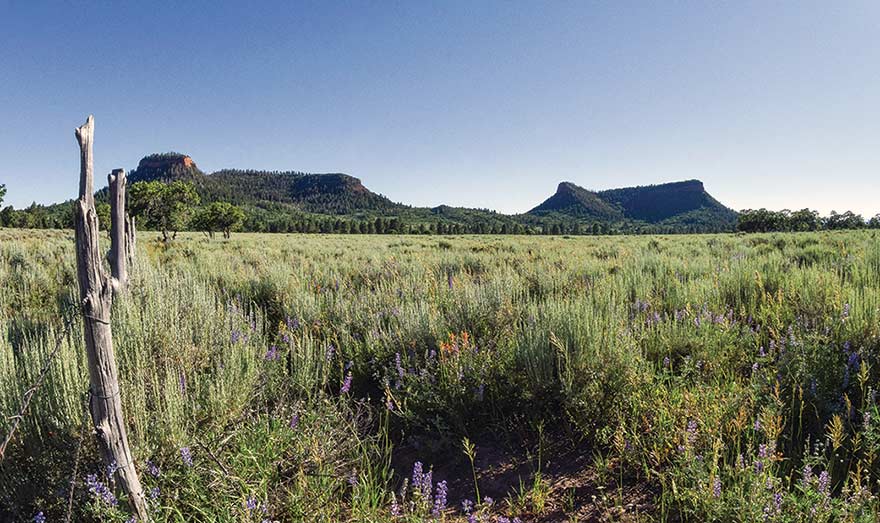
[0,0,880,216]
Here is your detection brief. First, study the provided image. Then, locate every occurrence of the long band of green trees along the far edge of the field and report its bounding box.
[0,180,880,236]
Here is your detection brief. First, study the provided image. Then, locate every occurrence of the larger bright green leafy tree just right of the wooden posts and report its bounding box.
[128,181,199,242]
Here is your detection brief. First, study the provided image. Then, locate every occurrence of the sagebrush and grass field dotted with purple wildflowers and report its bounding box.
[0,229,880,522]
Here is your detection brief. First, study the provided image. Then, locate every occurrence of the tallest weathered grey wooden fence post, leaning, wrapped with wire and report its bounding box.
[75,116,147,521]
